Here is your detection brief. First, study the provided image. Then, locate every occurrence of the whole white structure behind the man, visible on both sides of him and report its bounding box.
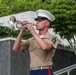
[0,11,69,45]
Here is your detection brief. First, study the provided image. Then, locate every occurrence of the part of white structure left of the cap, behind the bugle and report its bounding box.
[0,11,36,29]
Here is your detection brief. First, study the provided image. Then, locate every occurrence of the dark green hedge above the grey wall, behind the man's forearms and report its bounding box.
[0,26,32,40]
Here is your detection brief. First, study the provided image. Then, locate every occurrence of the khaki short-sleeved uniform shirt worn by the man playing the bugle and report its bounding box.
[23,32,58,68]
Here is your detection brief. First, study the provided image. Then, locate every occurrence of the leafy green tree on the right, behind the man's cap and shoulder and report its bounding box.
[48,0,76,49]
